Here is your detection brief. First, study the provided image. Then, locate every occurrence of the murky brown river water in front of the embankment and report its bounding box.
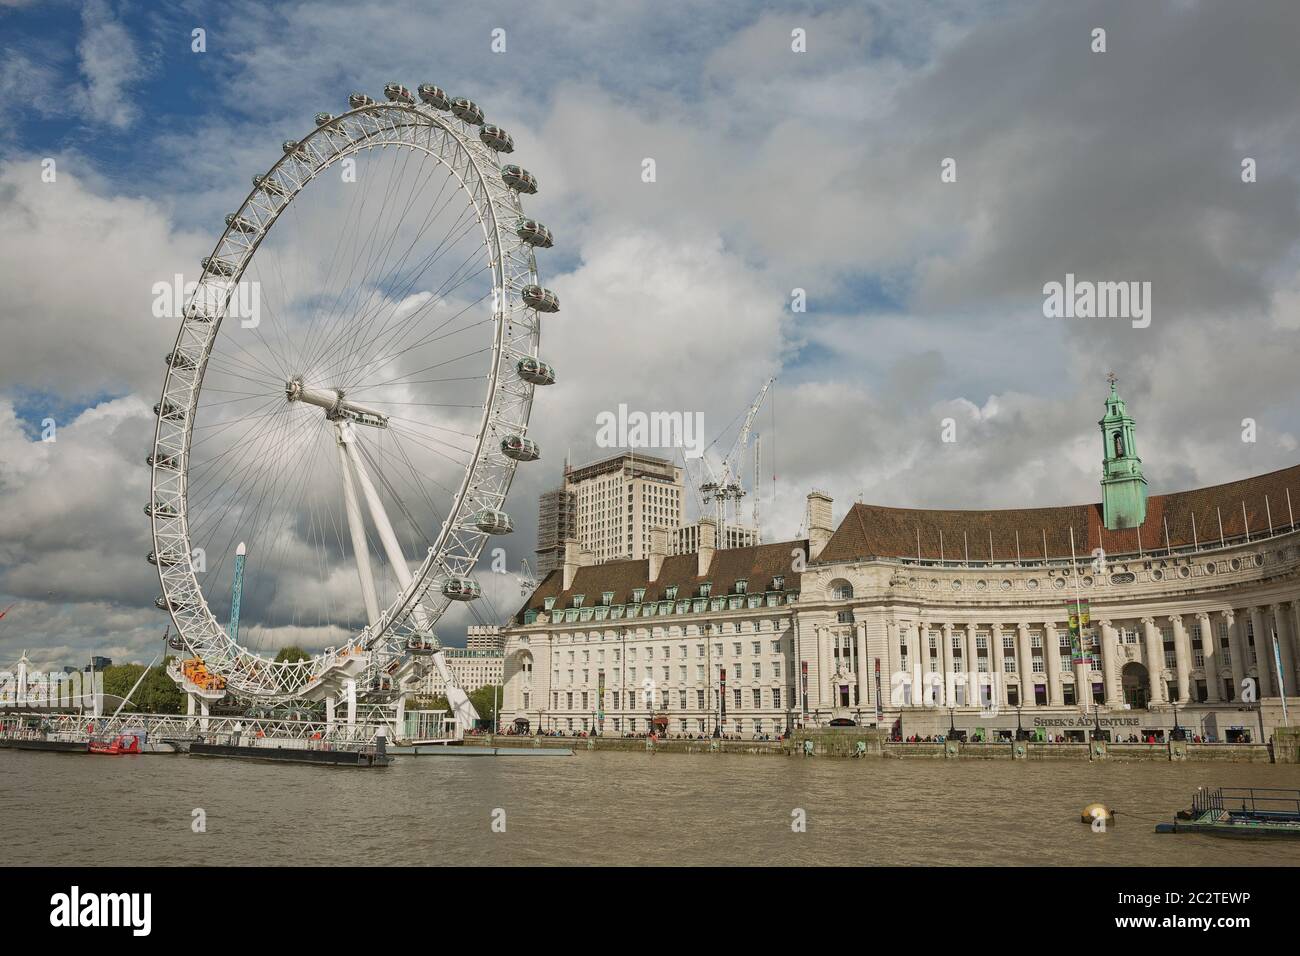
[0,752,1300,866]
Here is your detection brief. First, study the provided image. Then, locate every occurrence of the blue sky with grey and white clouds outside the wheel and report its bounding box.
[0,0,1300,666]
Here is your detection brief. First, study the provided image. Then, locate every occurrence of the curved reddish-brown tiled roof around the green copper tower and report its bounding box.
[818,466,1300,563]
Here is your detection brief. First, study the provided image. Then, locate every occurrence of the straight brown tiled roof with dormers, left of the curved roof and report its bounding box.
[515,538,809,622]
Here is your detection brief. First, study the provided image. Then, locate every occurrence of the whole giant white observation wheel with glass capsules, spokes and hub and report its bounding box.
[146,83,559,719]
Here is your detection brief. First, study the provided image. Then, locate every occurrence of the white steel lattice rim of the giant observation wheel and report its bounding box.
[148,95,540,701]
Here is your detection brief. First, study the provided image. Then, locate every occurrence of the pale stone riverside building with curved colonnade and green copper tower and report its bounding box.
[503,381,1300,740]
